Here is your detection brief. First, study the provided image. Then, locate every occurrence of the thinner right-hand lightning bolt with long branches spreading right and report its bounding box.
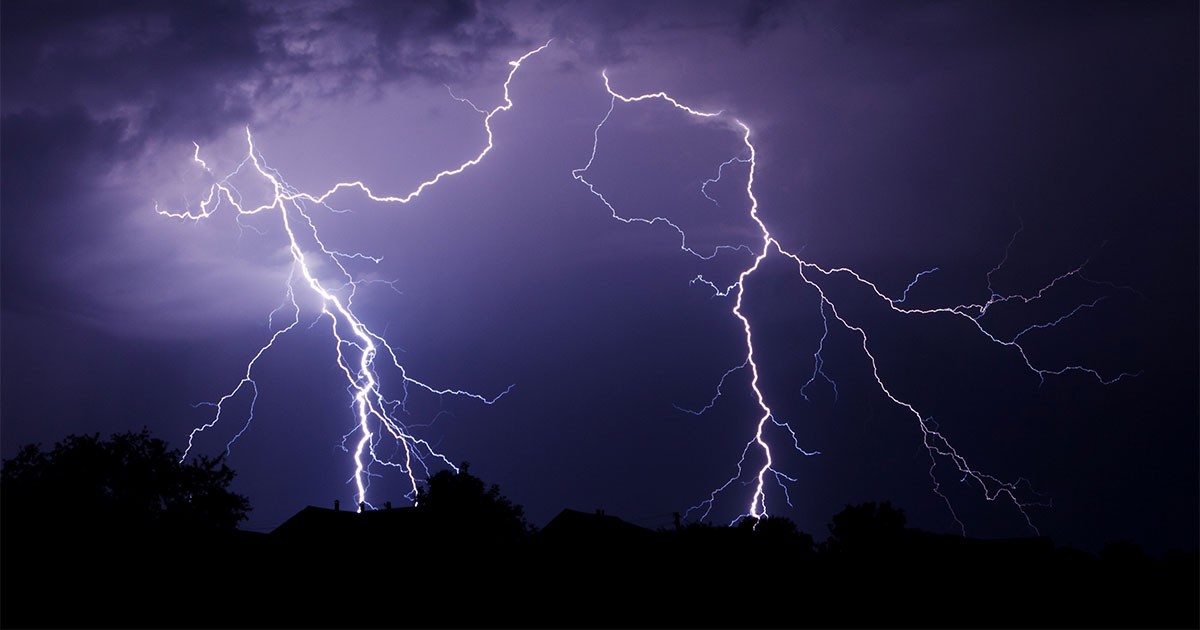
[571,71,1135,533]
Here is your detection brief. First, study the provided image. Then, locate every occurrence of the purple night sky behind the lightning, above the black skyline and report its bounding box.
[0,0,1200,552]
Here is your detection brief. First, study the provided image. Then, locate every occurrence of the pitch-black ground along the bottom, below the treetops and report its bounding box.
[2,508,1200,628]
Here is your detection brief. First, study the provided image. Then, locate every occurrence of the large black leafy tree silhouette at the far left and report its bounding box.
[0,428,250,533]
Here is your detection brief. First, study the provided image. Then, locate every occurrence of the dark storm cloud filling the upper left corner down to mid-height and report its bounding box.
[0,0,525,328]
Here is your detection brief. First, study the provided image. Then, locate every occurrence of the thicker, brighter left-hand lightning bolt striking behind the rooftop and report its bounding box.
[155,42,550,508]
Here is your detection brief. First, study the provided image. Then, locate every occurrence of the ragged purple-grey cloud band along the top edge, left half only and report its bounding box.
[2,0,514,139]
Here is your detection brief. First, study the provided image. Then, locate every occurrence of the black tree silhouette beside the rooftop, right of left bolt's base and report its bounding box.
[416,462,530,541]
